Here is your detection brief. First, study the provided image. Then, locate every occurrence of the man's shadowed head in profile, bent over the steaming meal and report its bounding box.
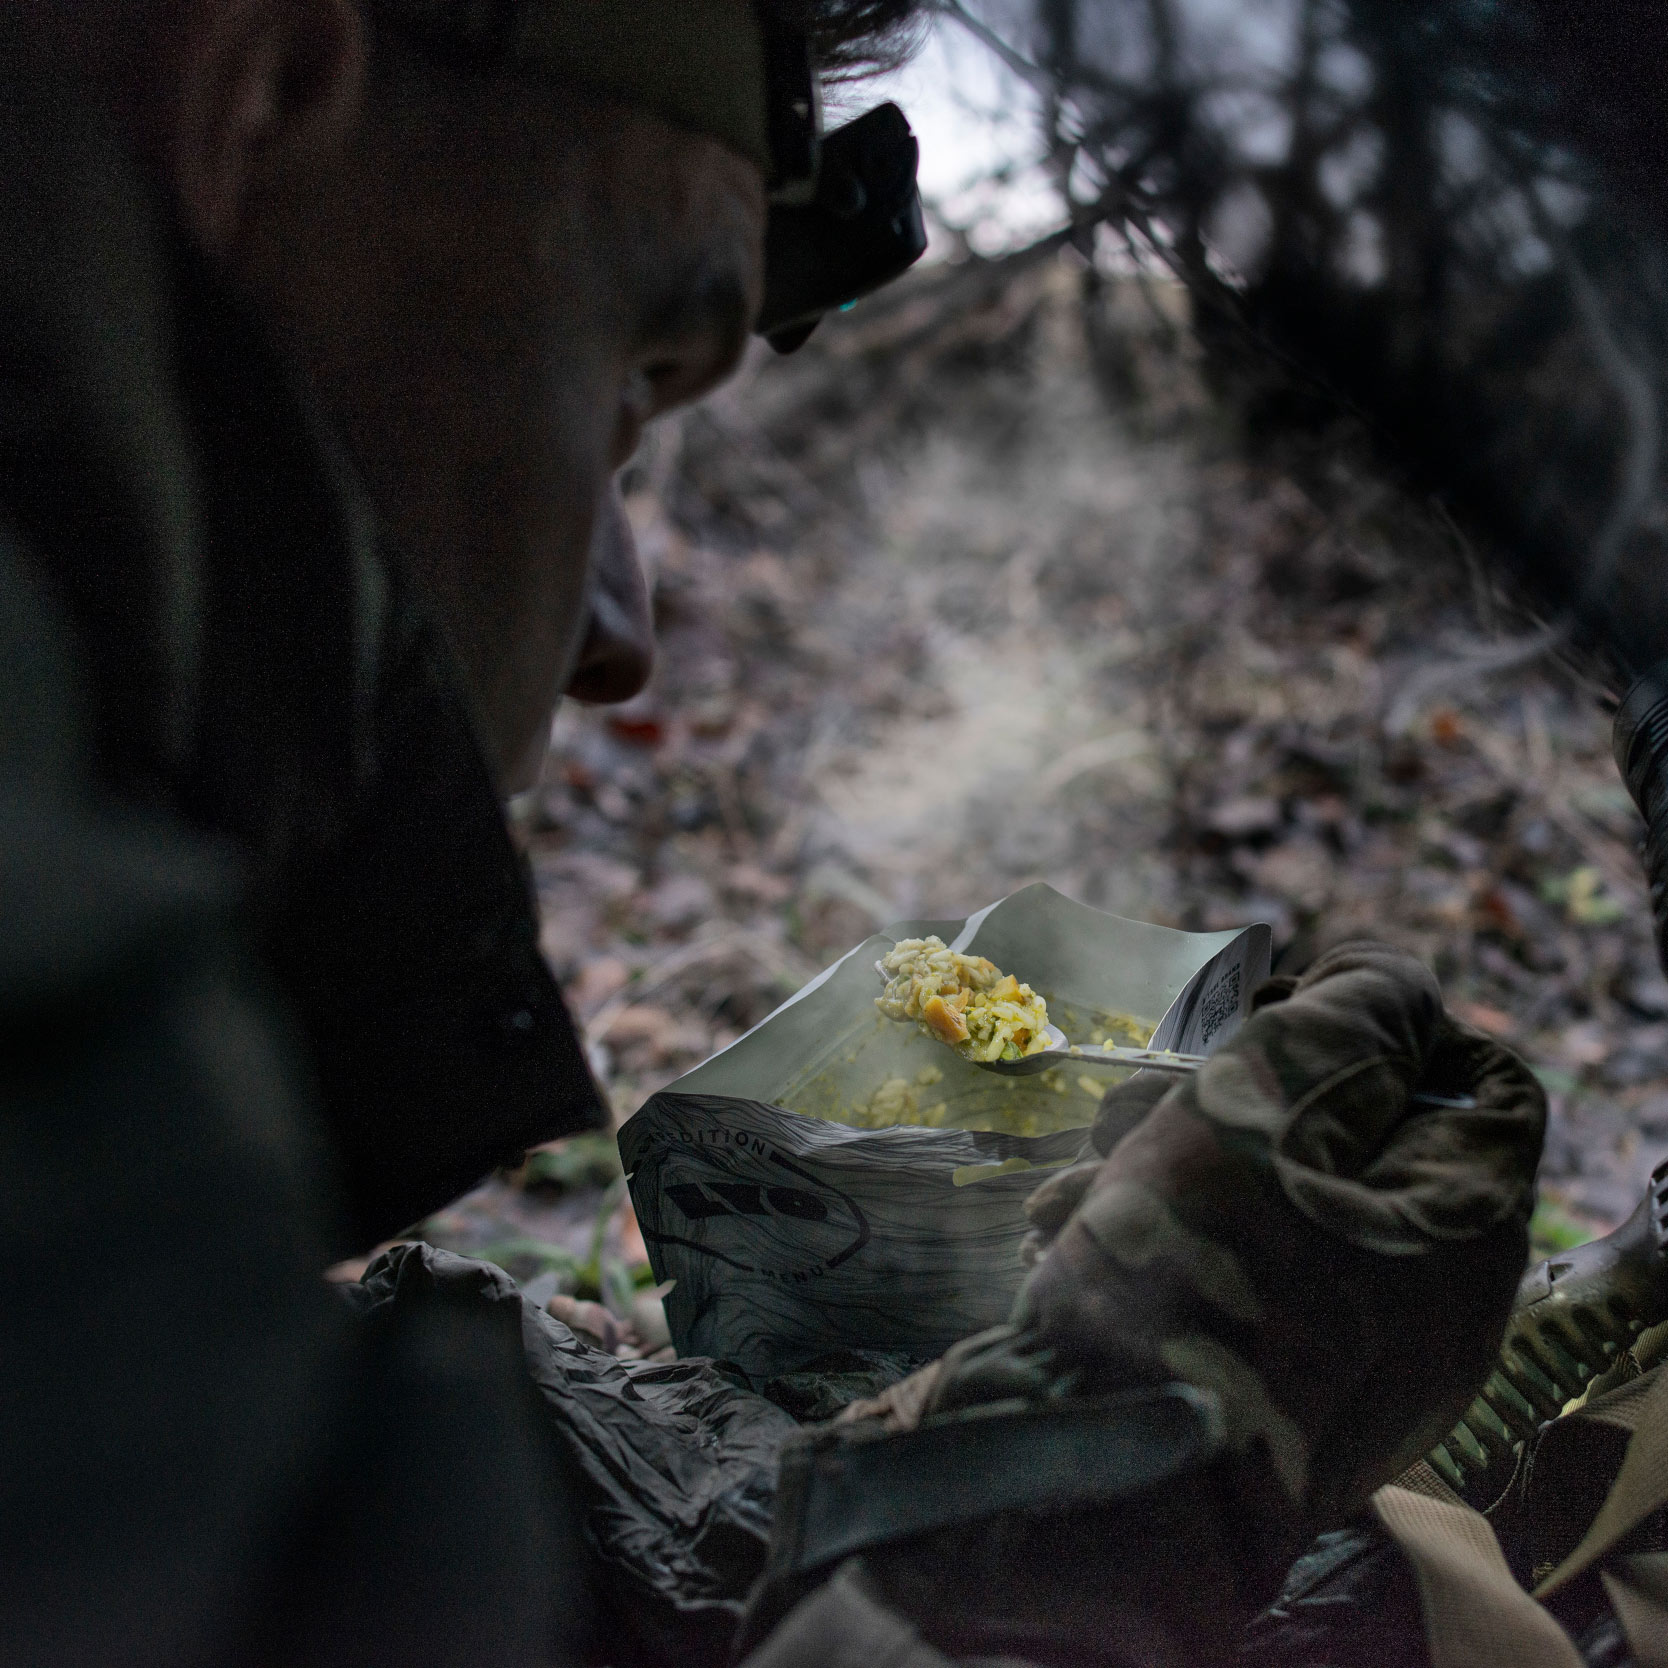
[65,0,911,787]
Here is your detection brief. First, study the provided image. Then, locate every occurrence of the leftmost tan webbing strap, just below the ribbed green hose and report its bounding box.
[1373,1485,1581,1668]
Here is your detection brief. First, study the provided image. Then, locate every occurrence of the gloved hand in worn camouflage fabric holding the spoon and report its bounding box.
[929,944,1546,1526]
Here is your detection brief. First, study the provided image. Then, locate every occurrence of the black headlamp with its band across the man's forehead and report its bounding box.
[369,0,927,354]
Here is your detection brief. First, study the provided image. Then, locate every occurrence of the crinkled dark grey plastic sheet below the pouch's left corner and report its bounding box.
[350,1244,797,1668]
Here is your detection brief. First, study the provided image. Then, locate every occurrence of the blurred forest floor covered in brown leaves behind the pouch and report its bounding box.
[427,252,1668,1314]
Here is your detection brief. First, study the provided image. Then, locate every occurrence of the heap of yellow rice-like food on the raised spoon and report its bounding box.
[874,937,1048,1061]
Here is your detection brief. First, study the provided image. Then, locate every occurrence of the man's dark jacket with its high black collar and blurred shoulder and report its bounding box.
[0,58,604,1668]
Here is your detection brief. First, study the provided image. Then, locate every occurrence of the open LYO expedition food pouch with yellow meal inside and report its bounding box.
[620,886,1271,1384]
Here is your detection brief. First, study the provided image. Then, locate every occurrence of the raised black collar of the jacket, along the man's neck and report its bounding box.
[0,71,605,1249]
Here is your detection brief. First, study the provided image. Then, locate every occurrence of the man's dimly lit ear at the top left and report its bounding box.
[157,0,365,255]
